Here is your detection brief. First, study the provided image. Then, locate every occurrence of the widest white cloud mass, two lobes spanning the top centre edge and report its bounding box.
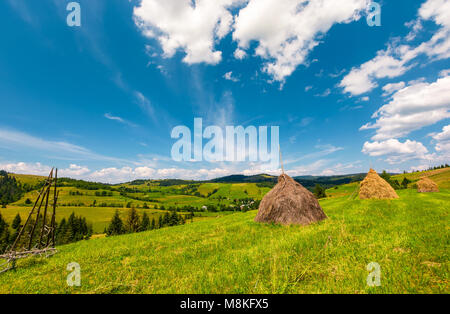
[134,0,369,81]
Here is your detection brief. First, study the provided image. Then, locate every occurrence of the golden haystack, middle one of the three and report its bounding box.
[359,169,398,200]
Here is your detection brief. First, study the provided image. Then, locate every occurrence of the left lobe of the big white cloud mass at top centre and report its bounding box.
[134,0,242,64]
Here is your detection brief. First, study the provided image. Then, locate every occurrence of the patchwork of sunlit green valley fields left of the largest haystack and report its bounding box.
[0,174,270,234]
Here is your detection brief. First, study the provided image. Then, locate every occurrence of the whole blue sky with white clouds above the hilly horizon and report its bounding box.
[0,0,450,182]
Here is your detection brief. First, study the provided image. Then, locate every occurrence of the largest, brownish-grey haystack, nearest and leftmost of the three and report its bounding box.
[255,174,327,225]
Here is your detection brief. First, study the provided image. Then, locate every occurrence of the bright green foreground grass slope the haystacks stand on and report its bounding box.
[0,188,450,293]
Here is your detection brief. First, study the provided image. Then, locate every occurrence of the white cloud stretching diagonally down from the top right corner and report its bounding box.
[339,0,450,95]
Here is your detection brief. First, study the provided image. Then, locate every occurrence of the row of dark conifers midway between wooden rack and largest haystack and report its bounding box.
[105,208,189,236]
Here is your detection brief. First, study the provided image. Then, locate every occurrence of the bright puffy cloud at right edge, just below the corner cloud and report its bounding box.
[361,76,450,140]
